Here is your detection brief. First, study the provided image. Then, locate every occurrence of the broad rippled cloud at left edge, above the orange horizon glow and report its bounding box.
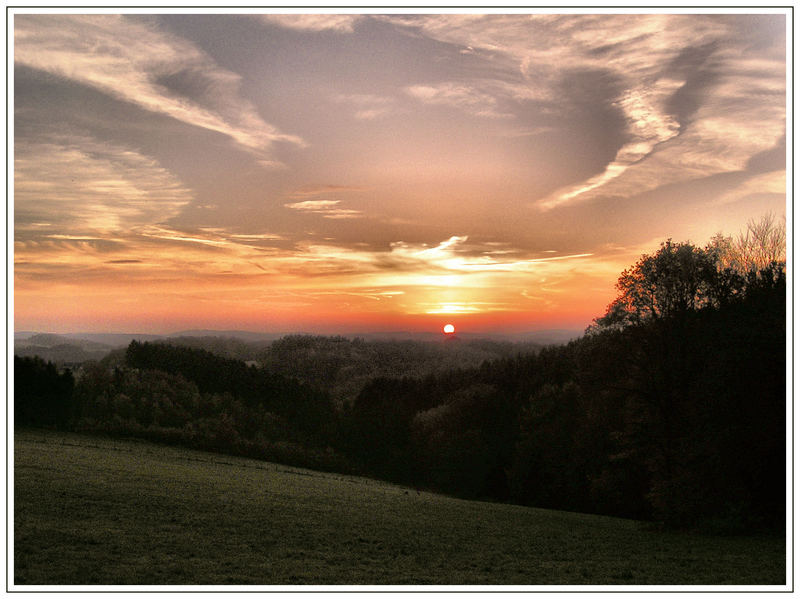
[14,129,296,289]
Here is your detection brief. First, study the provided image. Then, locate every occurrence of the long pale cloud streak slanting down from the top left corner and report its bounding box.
[14,15,304,166]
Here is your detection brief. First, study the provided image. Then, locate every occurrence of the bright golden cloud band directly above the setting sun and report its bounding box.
[252,236,619,314]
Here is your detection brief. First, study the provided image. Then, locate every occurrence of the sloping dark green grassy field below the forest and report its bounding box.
[13,430,785,585]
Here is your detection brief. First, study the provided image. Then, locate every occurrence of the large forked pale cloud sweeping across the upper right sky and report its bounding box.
[382,14,786,209]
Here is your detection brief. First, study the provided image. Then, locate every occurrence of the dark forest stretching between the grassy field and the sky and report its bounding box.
[14,221,787,533]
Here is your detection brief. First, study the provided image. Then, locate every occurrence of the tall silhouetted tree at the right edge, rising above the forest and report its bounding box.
[590,239,785,524]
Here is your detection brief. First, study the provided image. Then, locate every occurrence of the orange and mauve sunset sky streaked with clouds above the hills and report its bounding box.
[9,9,791,333]
